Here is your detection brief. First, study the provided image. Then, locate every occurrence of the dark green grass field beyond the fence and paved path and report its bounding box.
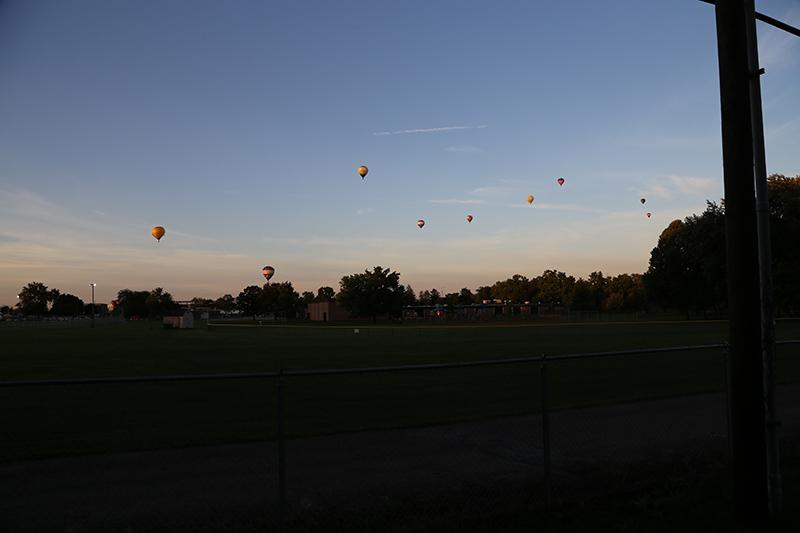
[0,321,800,461]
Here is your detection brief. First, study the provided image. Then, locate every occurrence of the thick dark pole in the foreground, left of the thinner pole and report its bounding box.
[715,0,768,525]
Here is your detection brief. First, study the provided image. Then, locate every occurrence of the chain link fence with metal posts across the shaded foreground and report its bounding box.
[0,342,800,532]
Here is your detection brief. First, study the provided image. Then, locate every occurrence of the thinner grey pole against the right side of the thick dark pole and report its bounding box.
[745,0,783,515]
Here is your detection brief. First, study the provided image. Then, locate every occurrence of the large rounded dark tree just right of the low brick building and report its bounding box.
[336,266,405,322]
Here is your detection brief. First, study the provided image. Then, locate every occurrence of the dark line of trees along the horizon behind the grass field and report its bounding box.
[3,174,800,320]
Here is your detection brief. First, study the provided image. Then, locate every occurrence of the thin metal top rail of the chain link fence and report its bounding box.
[0,340,736,387]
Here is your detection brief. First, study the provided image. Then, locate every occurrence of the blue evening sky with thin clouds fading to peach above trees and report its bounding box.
[0,0,800,305]
